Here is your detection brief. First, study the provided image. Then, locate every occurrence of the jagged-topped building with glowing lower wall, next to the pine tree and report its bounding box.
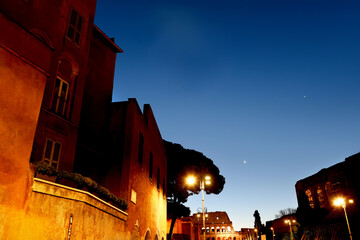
[107,99,167,240]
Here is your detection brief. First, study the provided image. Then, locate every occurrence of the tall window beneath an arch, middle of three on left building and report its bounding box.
[52,77,69,116]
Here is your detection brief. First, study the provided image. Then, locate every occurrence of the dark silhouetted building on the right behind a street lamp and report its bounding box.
[295,153,360,239]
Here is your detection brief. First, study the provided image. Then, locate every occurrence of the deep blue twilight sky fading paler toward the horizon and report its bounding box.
[95,0,360,230]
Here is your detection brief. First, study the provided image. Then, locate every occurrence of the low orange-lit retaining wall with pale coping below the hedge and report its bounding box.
[1,179,130,240]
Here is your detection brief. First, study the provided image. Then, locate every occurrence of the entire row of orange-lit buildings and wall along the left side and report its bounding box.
[0,0,167,240]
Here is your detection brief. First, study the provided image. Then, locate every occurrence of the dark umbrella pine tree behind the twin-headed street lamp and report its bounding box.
[163,140,225,239]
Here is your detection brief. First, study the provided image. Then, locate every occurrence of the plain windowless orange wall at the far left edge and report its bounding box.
[0,10,51,239]
